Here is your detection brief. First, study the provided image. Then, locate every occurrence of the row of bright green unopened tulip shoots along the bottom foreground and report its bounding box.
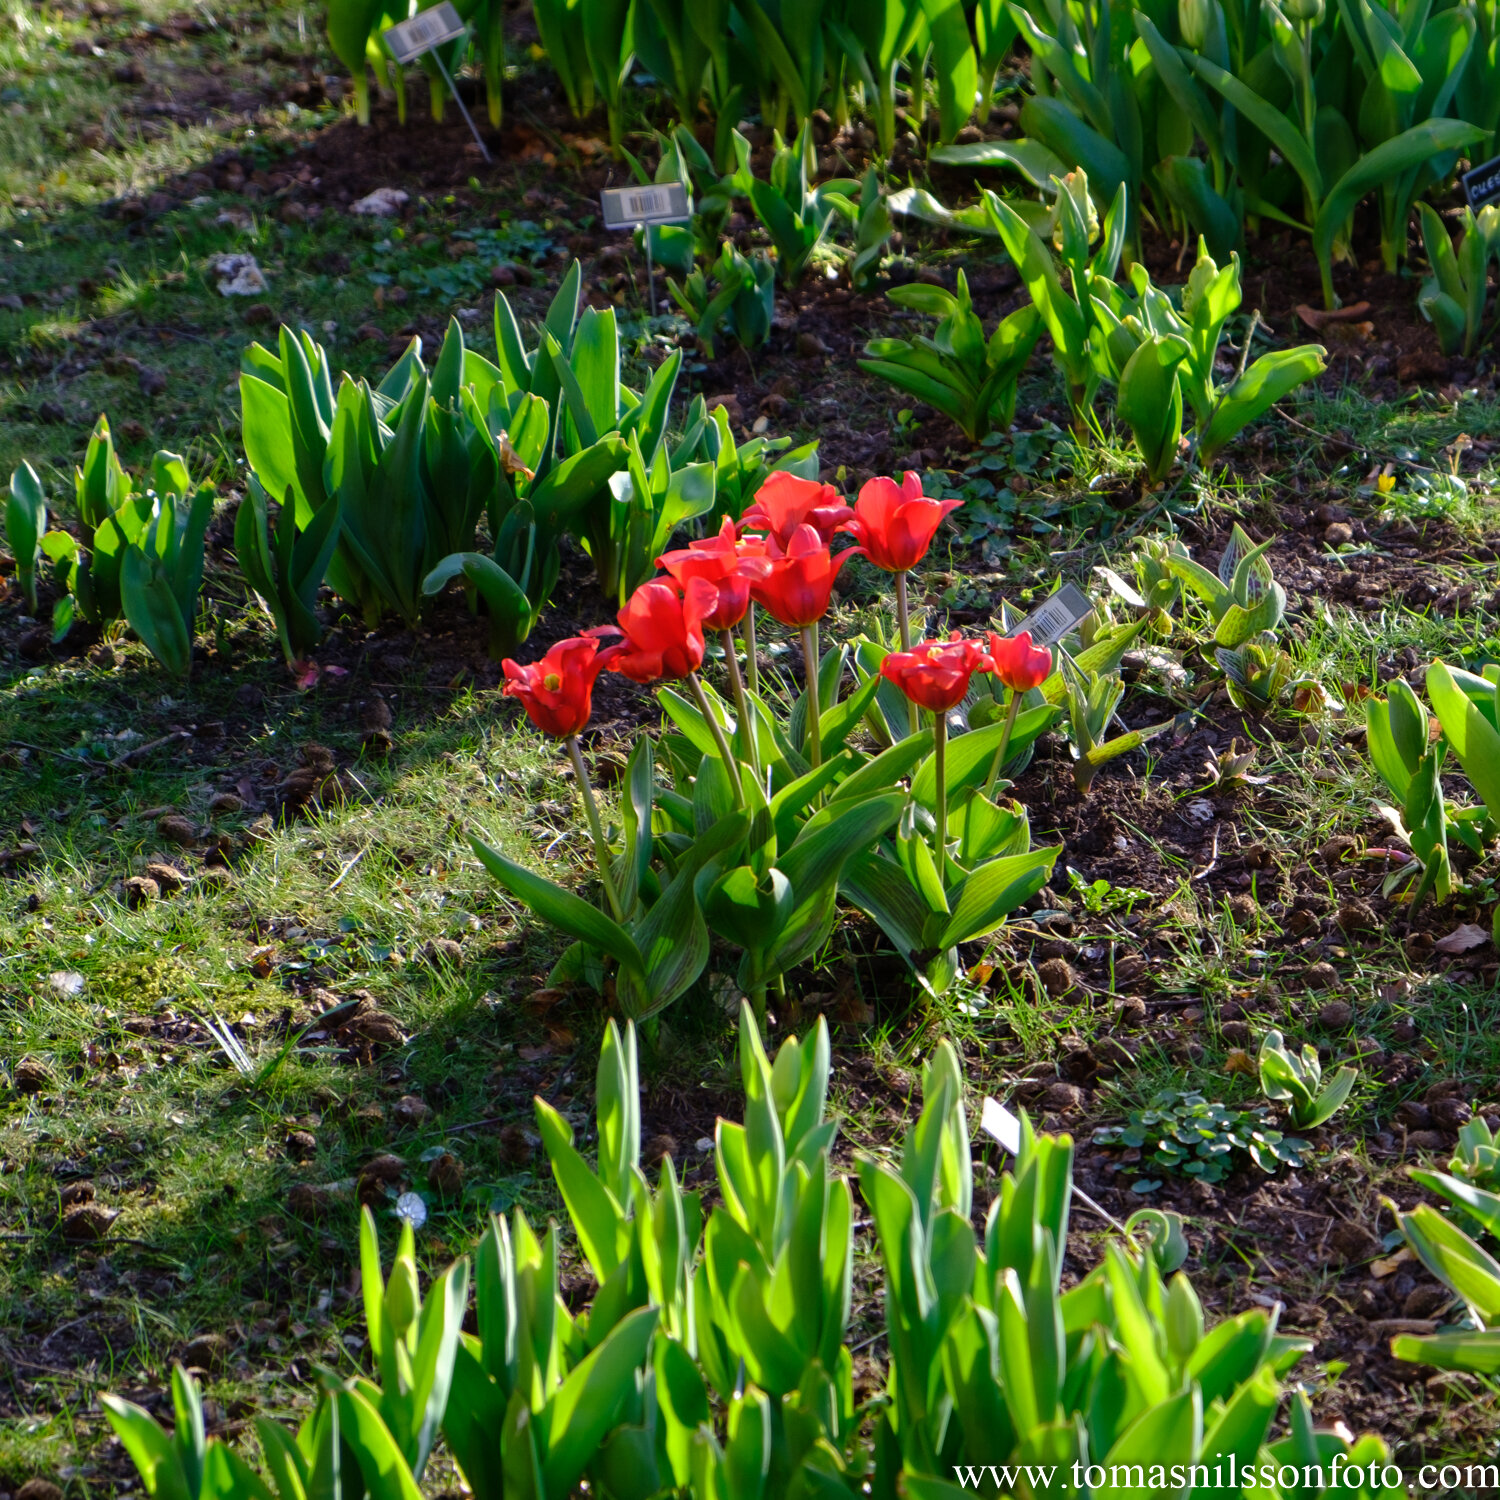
[104,1010,1434,1500]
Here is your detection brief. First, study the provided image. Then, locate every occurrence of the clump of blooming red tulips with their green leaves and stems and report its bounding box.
[476,473,1122,1019]
